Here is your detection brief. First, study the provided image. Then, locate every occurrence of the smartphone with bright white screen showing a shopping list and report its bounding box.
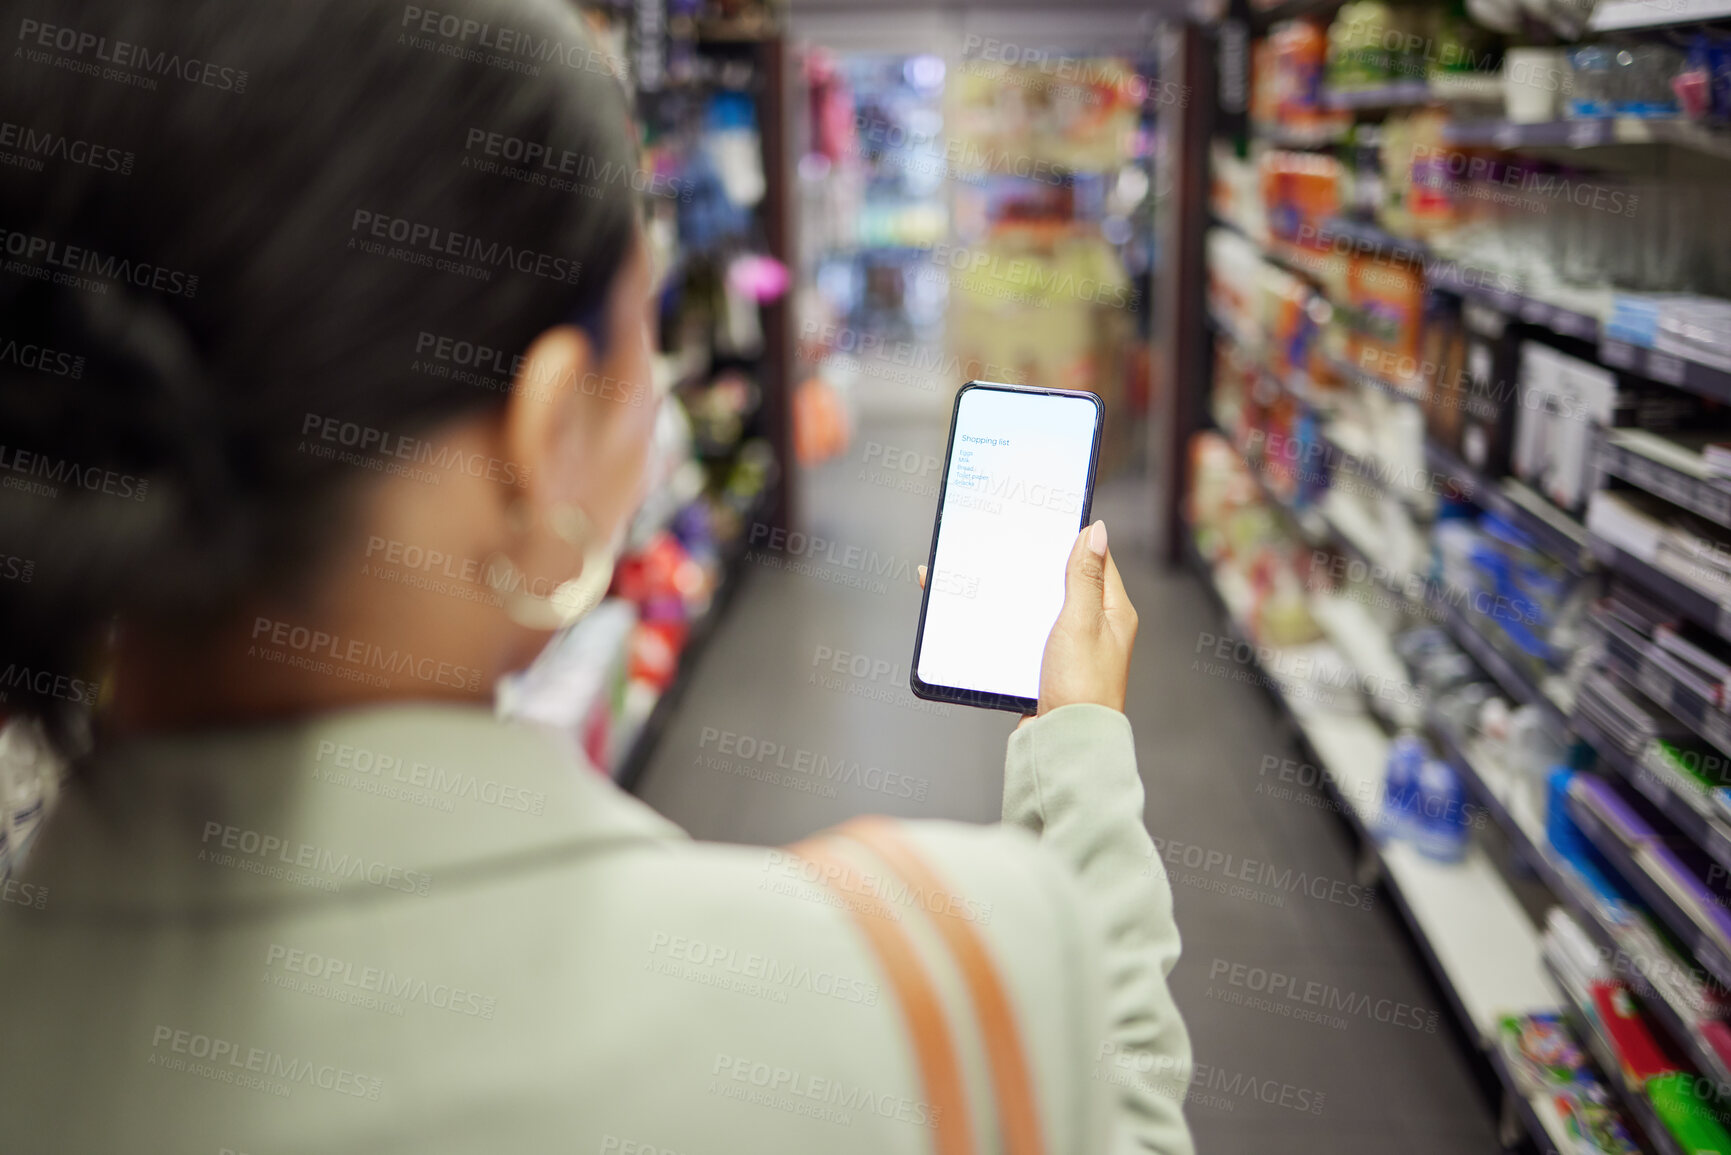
[909,381,1104,713]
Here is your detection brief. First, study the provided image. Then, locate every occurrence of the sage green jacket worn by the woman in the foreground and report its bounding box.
[0,705,1191,1155]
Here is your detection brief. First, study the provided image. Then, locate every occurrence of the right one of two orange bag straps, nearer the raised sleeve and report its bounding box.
[840,817,1044,1155]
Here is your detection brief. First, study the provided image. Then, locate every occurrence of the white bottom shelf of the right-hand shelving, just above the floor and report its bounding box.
[1186,535,1558,1048]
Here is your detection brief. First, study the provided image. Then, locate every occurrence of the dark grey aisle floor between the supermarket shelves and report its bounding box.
[639,414,1497,1155]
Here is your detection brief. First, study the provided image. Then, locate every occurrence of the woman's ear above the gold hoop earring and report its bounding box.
[502,326,594,511]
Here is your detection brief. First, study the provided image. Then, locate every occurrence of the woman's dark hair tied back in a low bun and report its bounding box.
[0,0,635,741]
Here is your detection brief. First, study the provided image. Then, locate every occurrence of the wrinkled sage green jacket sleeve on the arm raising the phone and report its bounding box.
[1004,705,1194,1155]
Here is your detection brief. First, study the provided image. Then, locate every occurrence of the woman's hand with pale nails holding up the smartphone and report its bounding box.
[919,521,1136,722]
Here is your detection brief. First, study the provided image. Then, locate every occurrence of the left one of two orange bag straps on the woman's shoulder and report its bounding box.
[789,836,975,1155]
